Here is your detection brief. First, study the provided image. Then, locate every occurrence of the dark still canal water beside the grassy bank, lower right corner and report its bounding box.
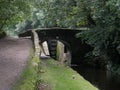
[72,65,120,90]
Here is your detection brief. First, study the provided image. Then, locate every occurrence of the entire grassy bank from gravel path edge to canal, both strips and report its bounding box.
[13,57,98,90]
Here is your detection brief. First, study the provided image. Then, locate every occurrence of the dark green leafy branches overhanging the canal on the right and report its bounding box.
[77,0,120,63]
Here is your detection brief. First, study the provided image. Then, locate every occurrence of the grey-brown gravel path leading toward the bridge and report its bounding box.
[0,37,32,90]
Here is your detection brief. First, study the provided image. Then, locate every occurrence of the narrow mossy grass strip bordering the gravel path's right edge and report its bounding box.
[13,57,39,90]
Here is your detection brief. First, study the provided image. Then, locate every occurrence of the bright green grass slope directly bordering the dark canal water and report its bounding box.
[40,60,98,90]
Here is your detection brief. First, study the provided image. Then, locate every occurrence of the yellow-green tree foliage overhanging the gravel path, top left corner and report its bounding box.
[0,0,33,33]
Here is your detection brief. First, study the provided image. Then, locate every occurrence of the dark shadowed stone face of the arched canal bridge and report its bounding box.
[19,28,91,63]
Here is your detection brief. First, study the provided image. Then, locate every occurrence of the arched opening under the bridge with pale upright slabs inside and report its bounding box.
[39,39,72,66]
